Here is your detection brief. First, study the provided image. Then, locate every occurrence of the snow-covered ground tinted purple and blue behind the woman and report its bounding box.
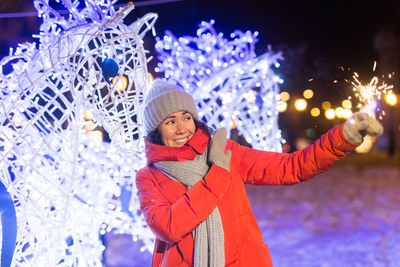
[105,165,400,267]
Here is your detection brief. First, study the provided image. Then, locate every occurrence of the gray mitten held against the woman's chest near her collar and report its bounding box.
[208,128,232,172]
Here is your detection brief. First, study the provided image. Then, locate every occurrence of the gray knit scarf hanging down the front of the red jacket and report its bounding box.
[153,149,225,267]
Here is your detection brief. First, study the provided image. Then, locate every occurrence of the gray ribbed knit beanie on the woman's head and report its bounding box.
[143,79,199,134]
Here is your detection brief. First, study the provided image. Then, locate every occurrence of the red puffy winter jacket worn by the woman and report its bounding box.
[136,125,357,267]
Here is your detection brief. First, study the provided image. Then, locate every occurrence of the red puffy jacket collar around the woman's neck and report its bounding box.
[145,129,210,165]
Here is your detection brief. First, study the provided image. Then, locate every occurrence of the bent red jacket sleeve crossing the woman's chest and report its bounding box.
[136,165,231,243]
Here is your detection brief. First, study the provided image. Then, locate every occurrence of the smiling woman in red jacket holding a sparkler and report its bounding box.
[136,79,382,267]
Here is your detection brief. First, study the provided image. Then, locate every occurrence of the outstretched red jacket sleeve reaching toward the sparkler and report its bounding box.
[230,124,359,185]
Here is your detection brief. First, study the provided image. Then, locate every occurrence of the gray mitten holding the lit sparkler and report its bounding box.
[343,112,383,144]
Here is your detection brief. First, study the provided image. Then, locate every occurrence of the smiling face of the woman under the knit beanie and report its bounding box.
[158,110,196,147]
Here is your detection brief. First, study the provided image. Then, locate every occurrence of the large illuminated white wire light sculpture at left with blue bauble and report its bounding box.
[0,0,157,266]
